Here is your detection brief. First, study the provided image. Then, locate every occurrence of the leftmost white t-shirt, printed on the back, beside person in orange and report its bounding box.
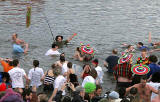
[8,67,26,88]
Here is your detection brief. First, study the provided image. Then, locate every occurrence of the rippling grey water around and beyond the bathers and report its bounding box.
[0,0,160,90]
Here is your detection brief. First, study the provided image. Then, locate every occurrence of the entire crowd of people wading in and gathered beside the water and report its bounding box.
[0,33,160,102]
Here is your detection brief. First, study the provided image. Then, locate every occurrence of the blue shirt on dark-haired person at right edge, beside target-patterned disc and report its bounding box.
[147,63,160,77]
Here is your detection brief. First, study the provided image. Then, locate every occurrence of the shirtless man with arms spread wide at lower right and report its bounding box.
[126,76,158,102]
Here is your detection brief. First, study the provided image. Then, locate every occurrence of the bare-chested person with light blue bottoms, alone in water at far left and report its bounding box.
[12,33,28,54]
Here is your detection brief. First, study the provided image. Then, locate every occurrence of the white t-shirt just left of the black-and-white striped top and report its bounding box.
[28,67,44,87]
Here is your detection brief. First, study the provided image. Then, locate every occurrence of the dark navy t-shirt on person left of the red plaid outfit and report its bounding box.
[105,55,119,73]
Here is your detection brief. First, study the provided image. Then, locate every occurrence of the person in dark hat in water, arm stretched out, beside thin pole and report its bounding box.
[53,33,77,48]
